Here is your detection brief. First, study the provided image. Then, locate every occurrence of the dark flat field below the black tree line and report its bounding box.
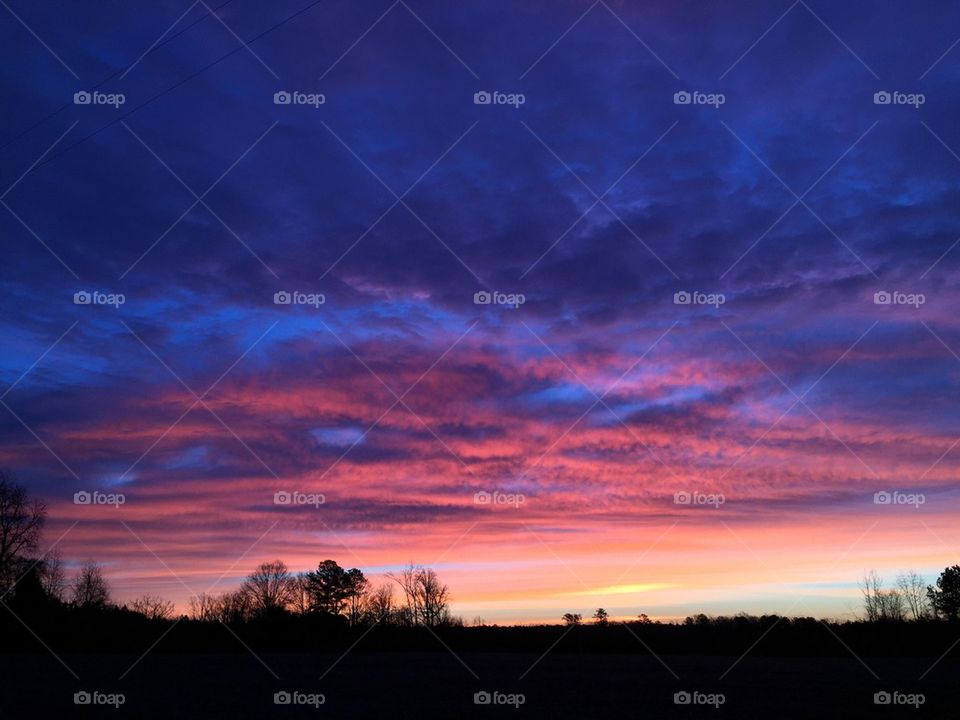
[0,651,960,720]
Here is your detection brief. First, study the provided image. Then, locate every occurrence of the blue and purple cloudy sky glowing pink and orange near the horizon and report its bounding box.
[0,0,960,623]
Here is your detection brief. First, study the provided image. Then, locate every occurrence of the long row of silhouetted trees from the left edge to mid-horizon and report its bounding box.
[0,471,454,627]
